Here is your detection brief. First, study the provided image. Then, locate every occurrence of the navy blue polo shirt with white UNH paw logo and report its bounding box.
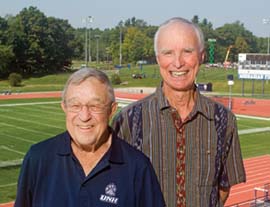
[15,132,165,207]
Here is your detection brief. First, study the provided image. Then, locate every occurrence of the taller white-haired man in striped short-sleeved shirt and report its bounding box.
[113,17,246,207]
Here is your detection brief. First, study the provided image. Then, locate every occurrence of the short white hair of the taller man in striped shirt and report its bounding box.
[154,17,204,55]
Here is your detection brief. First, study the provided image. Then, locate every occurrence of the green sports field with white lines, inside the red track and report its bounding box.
[0,98,270,203]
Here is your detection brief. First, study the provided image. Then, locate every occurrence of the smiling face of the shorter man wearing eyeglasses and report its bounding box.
[62,77,116,148]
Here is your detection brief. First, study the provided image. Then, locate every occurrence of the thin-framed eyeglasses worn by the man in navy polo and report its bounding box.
[65,103,109,114]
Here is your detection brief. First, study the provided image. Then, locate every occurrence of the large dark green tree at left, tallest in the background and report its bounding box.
[7,7,75,75]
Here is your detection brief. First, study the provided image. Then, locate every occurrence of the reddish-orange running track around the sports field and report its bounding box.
[0,92,270,207]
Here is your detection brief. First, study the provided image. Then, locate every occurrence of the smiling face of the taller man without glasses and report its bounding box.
[157,23,204,91]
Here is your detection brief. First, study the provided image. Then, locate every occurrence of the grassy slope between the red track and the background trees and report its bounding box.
[0,65,270,98]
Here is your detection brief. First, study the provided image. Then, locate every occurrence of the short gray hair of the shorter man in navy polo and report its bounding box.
[62,68,115,103]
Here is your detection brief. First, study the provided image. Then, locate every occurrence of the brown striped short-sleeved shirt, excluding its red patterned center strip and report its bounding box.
[112,84,246,207]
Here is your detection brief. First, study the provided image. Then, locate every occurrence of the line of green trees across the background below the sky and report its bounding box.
[0,7,267,78]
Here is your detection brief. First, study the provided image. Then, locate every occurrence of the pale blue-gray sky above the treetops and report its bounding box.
[0,0,270,37]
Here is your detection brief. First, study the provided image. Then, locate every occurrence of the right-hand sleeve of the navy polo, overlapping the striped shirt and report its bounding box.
[135,158,166,207]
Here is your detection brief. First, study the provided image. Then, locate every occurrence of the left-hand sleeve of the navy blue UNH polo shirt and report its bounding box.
[14,151,33,207]
